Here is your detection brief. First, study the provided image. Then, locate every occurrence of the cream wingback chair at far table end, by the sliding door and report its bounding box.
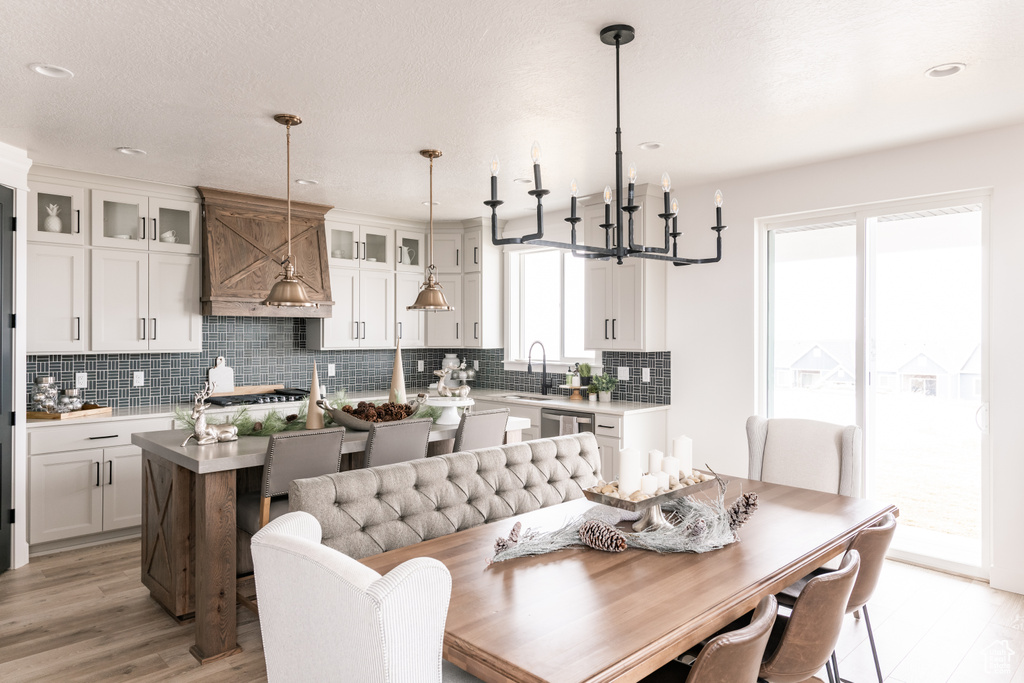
[746,415,861,496]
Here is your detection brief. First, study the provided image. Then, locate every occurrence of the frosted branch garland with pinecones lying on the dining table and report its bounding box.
[490,477,758,562]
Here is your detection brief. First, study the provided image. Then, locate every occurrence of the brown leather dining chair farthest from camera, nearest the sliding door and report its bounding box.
[777,514,896,683]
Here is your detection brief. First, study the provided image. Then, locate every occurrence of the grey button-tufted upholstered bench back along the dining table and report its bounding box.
[288,433,601,559]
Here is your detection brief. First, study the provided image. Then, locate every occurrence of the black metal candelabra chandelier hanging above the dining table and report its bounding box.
[483,24,726,265]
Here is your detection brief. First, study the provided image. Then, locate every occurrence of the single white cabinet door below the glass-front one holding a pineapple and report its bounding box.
[28,244,86,353]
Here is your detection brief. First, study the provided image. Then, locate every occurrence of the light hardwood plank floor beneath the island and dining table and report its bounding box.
[0,539,1024,683]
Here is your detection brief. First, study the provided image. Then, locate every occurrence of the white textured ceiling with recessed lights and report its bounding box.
[0,0,1024,219]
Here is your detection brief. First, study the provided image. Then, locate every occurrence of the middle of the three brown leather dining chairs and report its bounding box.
[759,550,860,683]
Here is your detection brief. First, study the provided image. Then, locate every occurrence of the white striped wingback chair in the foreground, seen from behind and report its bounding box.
[252,512,479,683]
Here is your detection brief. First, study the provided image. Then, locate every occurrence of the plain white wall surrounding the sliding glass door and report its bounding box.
[668,126,1024,593]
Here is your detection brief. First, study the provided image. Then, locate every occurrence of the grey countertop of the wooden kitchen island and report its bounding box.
[131,417,529,474]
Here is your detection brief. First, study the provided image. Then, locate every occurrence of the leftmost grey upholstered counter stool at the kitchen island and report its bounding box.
[236,427,345,589]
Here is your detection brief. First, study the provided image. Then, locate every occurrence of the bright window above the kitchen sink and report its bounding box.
[505,249,595,362]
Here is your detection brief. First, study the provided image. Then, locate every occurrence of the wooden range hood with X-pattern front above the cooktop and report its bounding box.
[197,187,334,317]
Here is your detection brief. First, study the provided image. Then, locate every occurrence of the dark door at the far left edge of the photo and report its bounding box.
[0,185,14,573]
